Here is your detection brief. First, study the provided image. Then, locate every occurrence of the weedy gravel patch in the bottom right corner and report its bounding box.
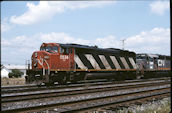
[100,97,171,113]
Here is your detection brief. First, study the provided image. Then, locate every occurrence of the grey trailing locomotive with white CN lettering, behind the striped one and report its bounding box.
[136,53,171,78]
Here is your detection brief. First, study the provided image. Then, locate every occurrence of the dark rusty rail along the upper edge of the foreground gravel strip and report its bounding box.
[1,82,170,103]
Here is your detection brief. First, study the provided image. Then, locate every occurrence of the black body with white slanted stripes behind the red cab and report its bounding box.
[72,45,136,80]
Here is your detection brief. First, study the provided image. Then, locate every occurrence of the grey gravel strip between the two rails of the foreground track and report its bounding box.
[2,85,170,110]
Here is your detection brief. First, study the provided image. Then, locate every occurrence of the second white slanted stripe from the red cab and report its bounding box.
[85,54,101,69]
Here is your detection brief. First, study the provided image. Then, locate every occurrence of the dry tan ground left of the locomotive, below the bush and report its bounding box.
[1,77,25,86]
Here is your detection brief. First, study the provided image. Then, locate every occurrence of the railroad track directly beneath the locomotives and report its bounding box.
[1,77,170,94]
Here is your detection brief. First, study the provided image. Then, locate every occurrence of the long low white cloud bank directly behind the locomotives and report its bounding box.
[1,28,170,64]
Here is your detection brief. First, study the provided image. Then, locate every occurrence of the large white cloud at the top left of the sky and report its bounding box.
[10,1,115,25]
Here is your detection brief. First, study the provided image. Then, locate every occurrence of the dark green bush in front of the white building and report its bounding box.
[8,69,23,78]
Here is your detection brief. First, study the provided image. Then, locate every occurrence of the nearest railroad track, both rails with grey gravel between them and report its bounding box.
[1,79,170,112]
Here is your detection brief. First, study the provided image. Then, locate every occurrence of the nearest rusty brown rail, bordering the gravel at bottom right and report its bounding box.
[2,88,170,113]
